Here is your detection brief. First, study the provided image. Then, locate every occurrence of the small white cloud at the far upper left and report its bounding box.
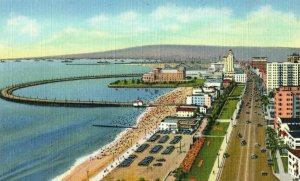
[7,15,40,36]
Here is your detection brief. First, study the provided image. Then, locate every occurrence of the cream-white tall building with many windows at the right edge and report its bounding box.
[266,62,300,93]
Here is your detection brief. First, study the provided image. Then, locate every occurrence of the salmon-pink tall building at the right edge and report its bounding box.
[274,87,300,118]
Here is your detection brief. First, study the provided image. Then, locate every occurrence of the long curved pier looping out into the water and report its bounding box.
[0,74,146,107]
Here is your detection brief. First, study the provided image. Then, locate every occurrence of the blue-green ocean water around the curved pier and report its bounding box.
[0,60,170,181]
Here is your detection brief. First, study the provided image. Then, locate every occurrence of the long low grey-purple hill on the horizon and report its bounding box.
[51,45,300,61]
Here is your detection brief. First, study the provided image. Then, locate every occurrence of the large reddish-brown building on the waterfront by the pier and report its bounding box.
[142,67,186,83]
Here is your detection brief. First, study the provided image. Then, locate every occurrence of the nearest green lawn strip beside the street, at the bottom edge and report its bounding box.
[184,137,223,181]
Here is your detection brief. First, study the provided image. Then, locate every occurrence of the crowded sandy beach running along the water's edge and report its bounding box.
[55,88,192,181]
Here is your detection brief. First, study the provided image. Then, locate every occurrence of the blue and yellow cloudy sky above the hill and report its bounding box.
[0,0,300,59]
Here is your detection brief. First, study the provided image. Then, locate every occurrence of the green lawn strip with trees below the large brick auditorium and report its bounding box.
[108,79,205,88]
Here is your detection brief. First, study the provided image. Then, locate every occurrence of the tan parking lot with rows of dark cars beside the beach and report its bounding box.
[104,131,192,180]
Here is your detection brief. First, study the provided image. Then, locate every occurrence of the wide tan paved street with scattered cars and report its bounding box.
[220,73,277,181]
